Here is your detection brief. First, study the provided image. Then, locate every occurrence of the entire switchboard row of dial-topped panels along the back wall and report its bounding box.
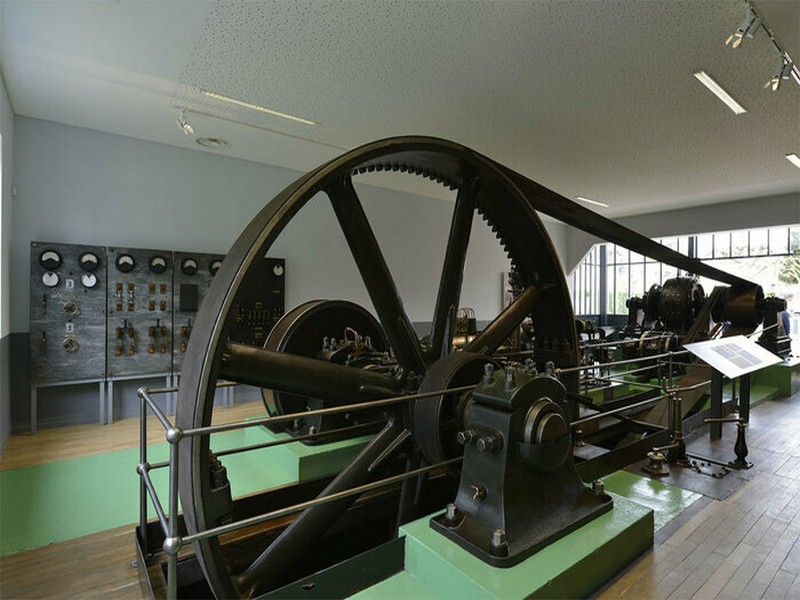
[30,242,286,384]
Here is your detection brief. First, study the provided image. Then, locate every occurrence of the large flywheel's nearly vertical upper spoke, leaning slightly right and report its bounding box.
[431,180,477,357]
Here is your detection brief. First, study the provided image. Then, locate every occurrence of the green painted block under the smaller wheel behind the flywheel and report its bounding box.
[263,427,373,481]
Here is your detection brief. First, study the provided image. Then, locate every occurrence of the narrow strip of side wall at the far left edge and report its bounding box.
[0,71,14,452]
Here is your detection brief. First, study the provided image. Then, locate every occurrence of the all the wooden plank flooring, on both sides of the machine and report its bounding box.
[0,394,800,599]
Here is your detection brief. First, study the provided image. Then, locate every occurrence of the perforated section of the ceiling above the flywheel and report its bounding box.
[169,0,797,204]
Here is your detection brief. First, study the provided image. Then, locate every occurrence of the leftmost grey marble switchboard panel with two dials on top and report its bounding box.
[30,242,107,383]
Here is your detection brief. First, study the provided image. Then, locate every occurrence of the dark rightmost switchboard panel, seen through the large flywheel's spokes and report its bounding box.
[229,256,286,347]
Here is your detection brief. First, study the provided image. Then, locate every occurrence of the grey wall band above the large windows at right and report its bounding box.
[562,193,800,272]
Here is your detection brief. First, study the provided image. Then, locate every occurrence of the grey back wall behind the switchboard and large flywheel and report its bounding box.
[10,117,566,429]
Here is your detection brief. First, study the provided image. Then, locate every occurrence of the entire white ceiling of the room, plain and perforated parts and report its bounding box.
[0,0,800,217]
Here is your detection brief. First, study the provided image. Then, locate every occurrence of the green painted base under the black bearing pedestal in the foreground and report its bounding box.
[353,496,653,600]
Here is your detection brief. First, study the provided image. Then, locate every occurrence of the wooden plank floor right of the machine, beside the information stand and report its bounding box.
[597,393,800,600]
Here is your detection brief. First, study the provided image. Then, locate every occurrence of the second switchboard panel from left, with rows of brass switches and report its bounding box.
[106,248,174,377]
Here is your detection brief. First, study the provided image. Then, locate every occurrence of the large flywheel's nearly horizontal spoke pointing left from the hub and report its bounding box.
[220,342,400,403]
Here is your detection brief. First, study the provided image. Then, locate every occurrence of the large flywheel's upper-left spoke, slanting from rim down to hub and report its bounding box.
[325,175,425,375]
